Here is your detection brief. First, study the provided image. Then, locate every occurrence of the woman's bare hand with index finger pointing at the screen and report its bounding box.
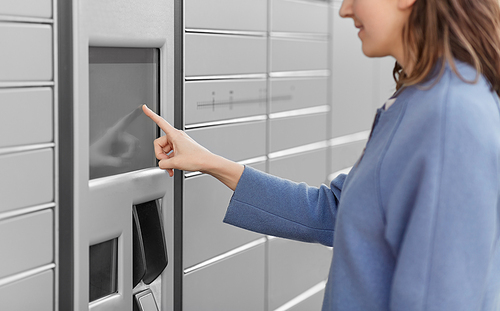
[142,105,244,190]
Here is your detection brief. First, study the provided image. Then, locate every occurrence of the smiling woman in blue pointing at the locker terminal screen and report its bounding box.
[144,0,500,310]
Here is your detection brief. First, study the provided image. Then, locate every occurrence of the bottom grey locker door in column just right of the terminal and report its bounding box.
[182,245,265,311]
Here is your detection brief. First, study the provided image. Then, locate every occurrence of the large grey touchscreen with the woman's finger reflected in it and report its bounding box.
[89,47,159,179]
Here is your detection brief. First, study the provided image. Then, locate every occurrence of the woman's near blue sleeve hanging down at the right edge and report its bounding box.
[380,82,500,311]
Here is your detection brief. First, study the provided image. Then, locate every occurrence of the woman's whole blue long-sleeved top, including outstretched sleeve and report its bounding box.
[224,63,500,311]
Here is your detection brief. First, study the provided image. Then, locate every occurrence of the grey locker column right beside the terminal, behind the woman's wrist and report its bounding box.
[184,0,268,310]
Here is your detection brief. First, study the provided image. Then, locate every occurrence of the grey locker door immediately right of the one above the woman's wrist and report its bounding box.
[270,113,327,152]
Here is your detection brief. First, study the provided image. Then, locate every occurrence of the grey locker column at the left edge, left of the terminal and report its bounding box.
[0,0,59,311]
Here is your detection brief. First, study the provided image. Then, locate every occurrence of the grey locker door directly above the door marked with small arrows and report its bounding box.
[185,34,267,77]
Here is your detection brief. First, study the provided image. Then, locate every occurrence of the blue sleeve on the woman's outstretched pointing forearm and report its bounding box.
[224,167,345,246]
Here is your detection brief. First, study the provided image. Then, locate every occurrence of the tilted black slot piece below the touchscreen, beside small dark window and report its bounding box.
[134,201,168,284]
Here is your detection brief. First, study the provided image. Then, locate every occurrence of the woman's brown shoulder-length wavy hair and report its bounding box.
[393,0,500,95]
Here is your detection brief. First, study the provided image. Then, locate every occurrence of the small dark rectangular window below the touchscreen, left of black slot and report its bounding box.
[89,239,118,302]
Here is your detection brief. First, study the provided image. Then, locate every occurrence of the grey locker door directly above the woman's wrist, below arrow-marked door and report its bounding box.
[186,121,266,161]
